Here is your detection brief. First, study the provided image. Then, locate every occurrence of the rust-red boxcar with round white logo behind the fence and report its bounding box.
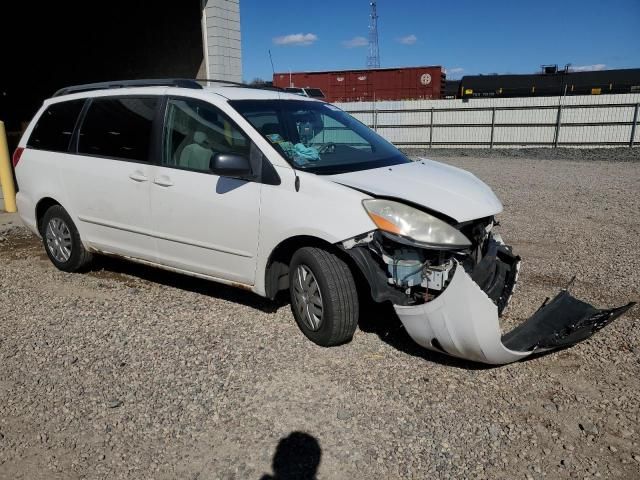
[273,66,446,102]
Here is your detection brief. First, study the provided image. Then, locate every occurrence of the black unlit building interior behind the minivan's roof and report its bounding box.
[0,0,203,147]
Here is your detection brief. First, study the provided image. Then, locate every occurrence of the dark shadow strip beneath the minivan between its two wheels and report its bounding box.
[88,255,288,313]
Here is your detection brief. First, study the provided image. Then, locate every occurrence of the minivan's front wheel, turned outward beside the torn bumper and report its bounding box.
[289,247,359,347]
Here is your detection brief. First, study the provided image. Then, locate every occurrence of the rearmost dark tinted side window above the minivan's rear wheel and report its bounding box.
[27,99,84,152]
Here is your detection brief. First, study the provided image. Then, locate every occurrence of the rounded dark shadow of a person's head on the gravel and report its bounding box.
[260,432,322,480]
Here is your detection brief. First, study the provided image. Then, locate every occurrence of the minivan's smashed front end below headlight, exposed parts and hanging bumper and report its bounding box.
[343,218,633,365]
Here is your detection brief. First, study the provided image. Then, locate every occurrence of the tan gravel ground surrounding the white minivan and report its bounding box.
[0,156,640,479]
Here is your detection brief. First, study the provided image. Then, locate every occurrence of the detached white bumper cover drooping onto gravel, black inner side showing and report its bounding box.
[395,265,634,365]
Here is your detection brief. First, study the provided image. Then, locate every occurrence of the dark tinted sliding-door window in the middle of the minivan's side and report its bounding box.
[78,97,158,162]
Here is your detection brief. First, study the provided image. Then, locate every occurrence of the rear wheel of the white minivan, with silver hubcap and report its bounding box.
[40,205,92,272]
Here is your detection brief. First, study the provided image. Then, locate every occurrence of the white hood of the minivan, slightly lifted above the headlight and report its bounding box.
[328,158,502,222]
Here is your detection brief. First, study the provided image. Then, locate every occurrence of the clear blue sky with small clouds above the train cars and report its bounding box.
[240,0,640,81]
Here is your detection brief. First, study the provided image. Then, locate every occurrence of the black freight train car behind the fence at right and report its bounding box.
[457,68,640,98]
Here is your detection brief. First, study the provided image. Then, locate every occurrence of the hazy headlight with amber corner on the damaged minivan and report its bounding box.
[362,199,471,249]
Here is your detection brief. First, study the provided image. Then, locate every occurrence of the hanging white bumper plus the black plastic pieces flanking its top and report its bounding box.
[347,229,634,365]
